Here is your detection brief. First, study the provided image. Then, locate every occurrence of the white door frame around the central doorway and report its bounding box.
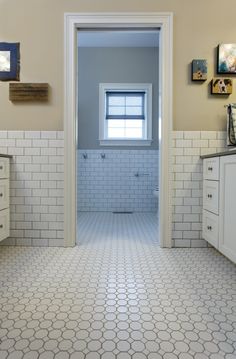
[64,13,173,248]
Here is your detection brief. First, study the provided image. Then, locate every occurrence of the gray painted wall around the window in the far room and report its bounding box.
[78,47,158,149]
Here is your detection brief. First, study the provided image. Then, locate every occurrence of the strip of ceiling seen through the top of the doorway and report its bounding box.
[78,30,159,47]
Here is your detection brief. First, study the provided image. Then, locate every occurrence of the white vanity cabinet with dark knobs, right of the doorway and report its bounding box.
[202,152,236,263]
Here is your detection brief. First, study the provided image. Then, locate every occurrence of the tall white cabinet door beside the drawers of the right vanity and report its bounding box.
[219,155,236,263]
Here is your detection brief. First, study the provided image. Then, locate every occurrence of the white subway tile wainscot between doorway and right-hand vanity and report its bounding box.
[172,131,226,247]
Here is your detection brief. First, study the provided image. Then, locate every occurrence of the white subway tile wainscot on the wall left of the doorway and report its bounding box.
[0,131,64,246]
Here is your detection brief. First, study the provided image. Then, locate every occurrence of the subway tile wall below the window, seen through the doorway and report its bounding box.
[77,150,158,212]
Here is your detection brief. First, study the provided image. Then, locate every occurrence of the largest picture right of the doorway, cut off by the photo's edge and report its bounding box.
[217,44,236,74]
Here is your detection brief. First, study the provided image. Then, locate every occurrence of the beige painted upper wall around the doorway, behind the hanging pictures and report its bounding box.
[0,0,236,130]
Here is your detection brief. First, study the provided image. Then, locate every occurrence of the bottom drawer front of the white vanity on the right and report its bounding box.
[202,210,219,249]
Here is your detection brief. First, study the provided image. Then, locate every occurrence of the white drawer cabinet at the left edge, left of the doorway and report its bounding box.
[0,157,10,241]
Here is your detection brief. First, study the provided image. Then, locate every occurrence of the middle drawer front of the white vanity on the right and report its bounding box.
[203,181,219,214]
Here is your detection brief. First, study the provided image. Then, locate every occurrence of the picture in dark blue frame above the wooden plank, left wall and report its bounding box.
[0,42,20,81]
